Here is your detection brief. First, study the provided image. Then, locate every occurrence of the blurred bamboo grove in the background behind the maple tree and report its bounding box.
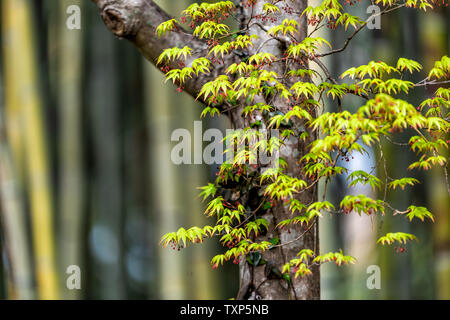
[0,0,450,299]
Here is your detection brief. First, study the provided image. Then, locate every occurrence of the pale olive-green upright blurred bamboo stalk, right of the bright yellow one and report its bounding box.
[55,0,83,299]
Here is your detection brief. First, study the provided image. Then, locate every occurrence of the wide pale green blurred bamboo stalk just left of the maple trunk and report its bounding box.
[145,0,217,299]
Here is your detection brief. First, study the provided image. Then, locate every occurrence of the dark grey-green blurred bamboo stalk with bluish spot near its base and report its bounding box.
[83,10,127,299]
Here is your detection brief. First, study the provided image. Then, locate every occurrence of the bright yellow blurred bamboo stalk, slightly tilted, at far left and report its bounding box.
[2,0,58,299]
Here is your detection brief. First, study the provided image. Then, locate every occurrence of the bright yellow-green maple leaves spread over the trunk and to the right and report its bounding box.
[157,0,444,277]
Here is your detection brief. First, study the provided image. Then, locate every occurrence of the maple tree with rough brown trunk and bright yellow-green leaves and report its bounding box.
[93,0,450,299]
